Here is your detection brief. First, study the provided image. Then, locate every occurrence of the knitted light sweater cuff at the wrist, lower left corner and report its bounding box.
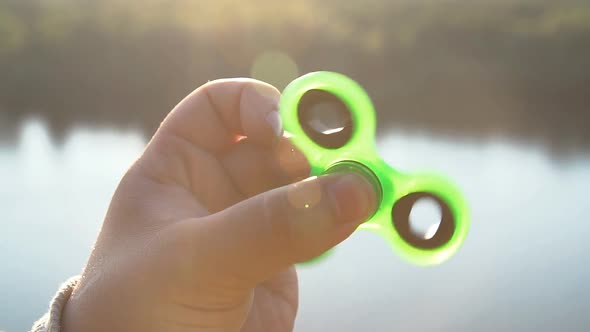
[30,276,80,332]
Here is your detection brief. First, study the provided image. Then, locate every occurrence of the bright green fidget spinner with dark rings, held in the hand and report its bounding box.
[280,72,469,265]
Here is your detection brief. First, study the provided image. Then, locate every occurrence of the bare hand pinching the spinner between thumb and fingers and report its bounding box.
[62,79,376,332]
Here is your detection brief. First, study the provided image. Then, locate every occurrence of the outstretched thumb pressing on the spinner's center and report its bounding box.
[198,173,377,283]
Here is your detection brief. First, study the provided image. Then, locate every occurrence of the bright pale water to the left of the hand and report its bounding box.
[0,118,144,332]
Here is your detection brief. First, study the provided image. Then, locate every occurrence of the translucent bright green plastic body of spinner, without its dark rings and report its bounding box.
[279,72,469,265]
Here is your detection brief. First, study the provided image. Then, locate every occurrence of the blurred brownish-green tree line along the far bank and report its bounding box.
[0,0,590,153]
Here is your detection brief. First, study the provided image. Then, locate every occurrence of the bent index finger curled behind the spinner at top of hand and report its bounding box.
[156,78,283,153]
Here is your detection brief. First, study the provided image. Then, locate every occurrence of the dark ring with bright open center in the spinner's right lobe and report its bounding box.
[392,192,456,249]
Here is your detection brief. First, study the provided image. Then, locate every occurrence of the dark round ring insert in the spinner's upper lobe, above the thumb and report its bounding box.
[297,90,354,149]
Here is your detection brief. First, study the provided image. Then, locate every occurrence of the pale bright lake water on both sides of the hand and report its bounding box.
[0,121,590,332]
